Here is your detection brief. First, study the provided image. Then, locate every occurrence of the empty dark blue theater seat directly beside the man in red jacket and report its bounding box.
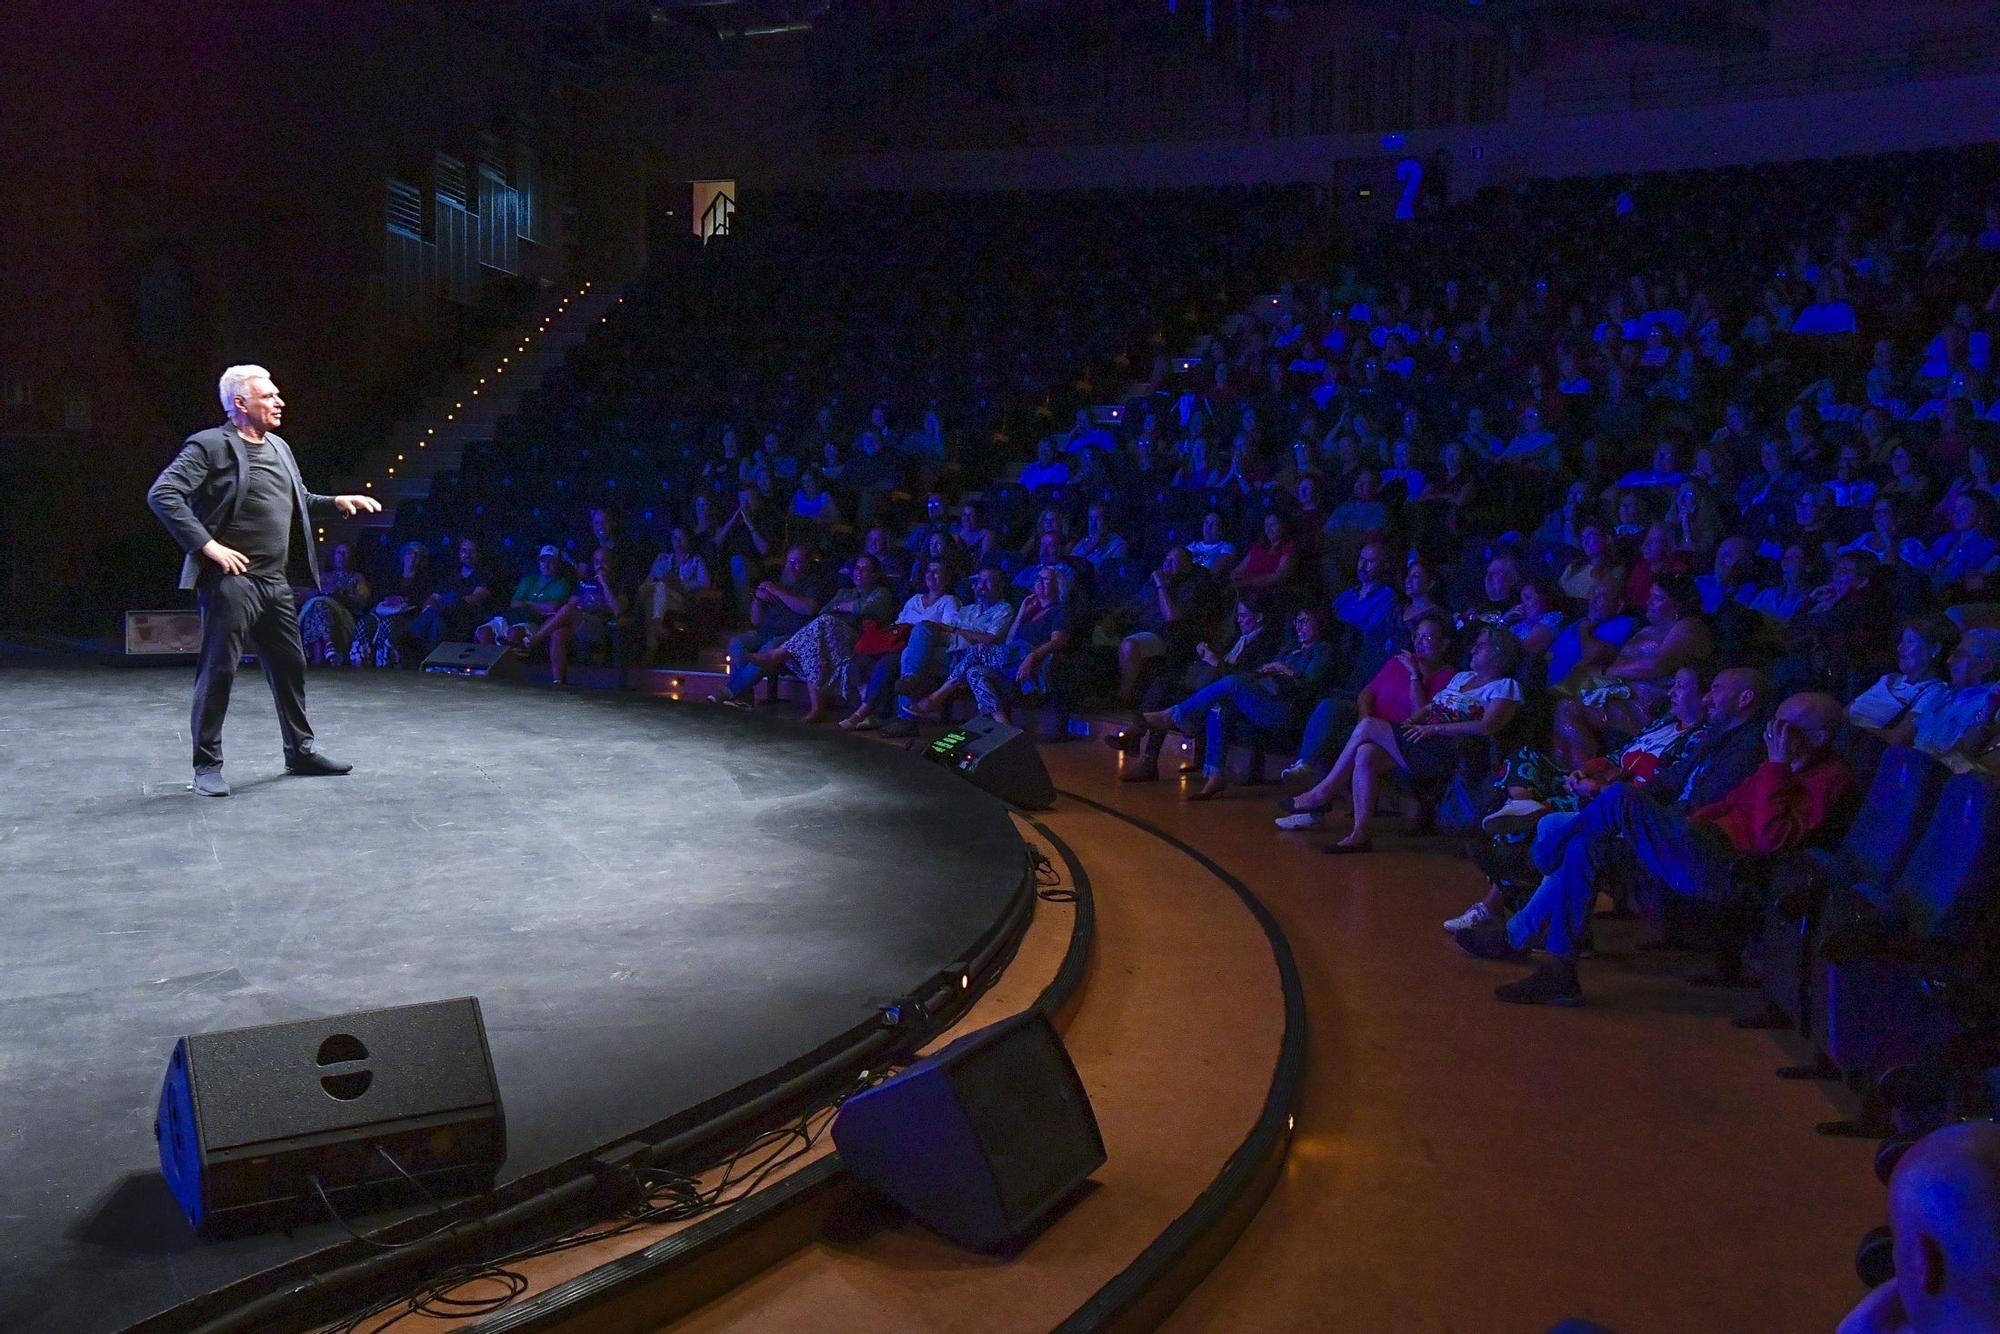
[1756,746,1952,1036]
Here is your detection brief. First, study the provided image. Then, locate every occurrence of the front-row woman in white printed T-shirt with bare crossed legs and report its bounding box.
[1280,626,1522,852]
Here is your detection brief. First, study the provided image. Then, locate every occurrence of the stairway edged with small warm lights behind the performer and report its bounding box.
[322,282,620,542]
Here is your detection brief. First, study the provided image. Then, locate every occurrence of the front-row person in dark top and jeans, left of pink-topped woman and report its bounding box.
[1120,606,1334,802]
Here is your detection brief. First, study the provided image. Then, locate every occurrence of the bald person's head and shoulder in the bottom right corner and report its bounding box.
[1838,1122,2000,1334]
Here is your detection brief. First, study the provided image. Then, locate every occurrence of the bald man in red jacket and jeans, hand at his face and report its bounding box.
[1460,694,1854,1006]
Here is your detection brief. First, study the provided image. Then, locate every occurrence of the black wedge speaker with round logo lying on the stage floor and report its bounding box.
[152,996,506,1234]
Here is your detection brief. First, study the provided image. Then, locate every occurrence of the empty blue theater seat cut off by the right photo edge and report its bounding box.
[1808,774,2000,1074]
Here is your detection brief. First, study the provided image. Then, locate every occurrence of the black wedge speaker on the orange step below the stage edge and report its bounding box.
[834,1010,1104,1252]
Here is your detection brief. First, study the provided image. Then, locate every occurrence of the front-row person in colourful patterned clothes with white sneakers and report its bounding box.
[1444,668,1710,932]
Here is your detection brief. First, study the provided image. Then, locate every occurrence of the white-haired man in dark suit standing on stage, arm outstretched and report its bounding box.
[146,366,382,796]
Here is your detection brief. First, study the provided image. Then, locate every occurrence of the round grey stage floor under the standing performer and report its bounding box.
[0,668,1024,1334]
